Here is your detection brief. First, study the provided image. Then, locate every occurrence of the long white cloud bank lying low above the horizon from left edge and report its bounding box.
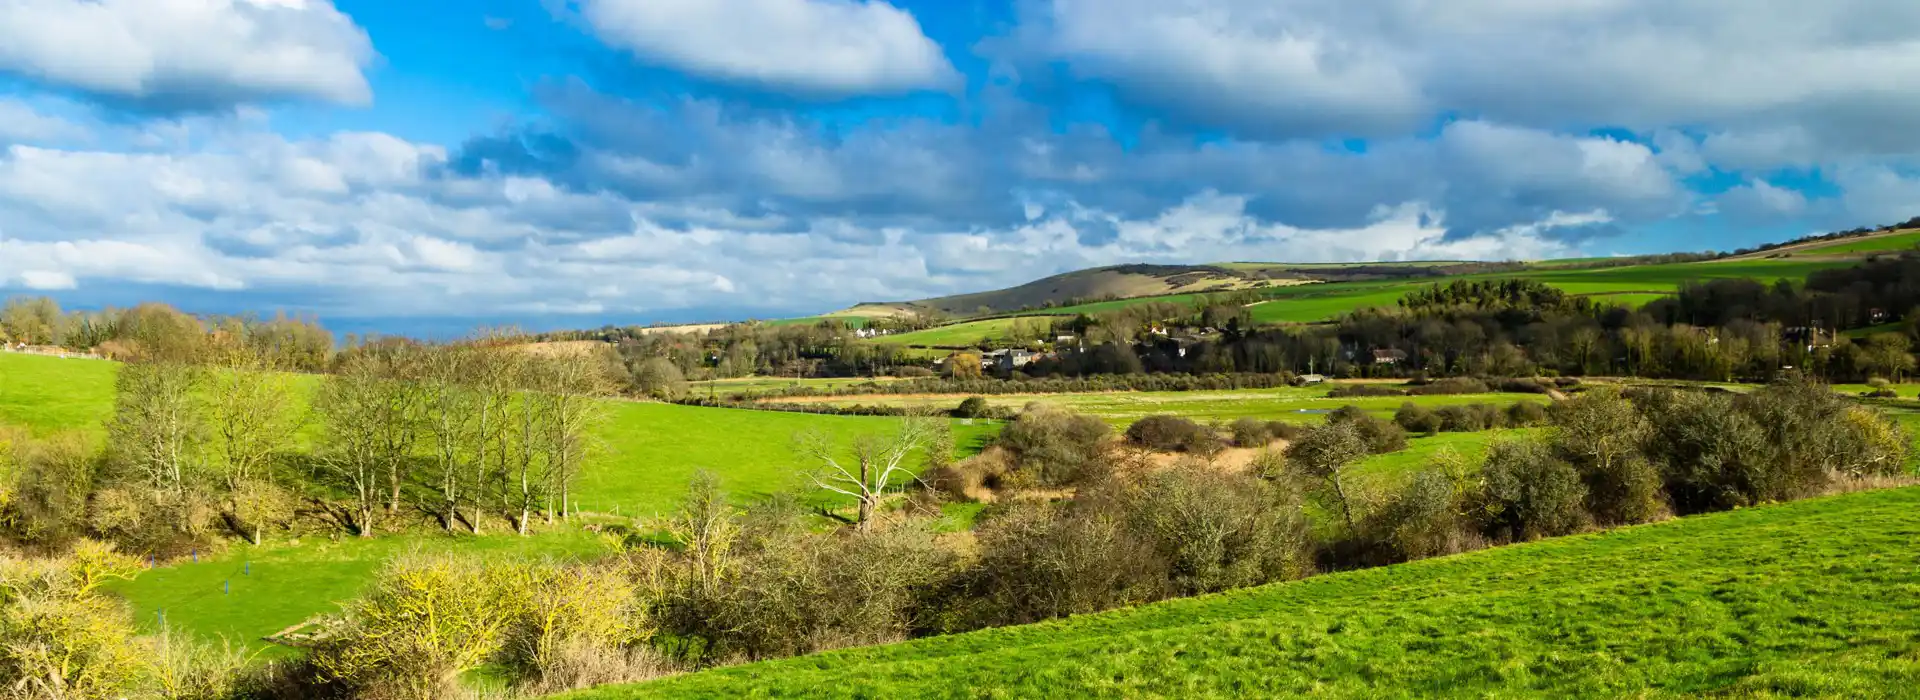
[0,117,1569,316]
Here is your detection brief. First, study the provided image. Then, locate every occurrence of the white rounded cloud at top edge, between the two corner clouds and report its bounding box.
[580,0,960,96]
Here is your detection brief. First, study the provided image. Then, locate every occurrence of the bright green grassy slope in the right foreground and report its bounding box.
[566,489,1920,700]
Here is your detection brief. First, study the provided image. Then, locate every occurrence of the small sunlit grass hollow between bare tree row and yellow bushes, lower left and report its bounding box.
[108,529,609,656]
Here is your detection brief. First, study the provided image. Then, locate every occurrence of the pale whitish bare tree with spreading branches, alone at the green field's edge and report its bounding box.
[801,416,937,531]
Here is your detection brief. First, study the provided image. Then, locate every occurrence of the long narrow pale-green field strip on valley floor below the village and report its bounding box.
[756,387,1548,426]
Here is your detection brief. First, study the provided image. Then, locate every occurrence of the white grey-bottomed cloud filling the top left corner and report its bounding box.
[0,0,374,111]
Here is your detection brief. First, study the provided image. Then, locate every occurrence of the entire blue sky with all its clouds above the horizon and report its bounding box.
[0,0,1920,332]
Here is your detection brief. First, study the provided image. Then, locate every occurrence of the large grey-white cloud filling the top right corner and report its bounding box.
[1014,0,1920,148]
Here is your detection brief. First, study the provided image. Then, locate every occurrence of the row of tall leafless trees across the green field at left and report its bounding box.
[0,334,612,556]
